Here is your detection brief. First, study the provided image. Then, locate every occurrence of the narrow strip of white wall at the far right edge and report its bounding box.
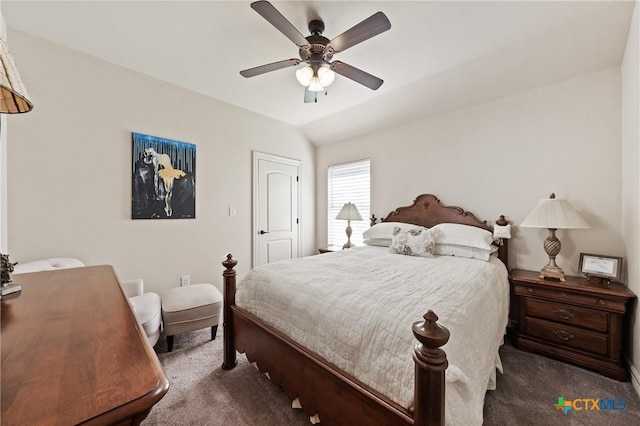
[622,2,640,394]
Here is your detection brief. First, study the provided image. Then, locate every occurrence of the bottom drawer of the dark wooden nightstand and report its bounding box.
[525,317,609,356]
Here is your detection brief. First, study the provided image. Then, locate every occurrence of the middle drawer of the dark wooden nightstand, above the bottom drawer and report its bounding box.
[525,298,609,333]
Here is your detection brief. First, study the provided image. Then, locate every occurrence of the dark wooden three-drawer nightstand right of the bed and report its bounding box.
[510,269,636,381]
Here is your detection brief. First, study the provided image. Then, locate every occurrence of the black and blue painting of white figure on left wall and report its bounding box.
[131,133,196,219]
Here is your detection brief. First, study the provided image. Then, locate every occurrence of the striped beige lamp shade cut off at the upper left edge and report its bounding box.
[0,38,33,114]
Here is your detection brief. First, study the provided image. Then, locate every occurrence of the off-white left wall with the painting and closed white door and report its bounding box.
[8,31,317,292]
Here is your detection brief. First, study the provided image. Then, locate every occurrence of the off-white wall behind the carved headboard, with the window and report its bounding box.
[316,68,624,274]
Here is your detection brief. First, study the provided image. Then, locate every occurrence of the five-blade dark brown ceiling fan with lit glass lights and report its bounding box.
[240,1,391,102]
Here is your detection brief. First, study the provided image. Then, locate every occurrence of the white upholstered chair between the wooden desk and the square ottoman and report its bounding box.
[120,278,162,346]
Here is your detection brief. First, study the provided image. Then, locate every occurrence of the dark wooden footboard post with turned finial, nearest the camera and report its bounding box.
[413,310,449,426]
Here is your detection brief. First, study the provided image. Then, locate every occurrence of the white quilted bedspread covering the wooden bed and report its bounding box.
[236,246,509,425]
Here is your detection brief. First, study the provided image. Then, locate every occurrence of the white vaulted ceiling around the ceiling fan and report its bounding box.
[0,0,634,145]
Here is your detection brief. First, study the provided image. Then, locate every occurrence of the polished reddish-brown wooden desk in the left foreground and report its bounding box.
[1,266,169,426]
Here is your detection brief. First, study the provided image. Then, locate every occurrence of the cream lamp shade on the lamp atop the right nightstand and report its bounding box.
[520,194,590,229]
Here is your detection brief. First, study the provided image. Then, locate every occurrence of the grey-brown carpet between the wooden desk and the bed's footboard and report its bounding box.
[142,327,311,426]
